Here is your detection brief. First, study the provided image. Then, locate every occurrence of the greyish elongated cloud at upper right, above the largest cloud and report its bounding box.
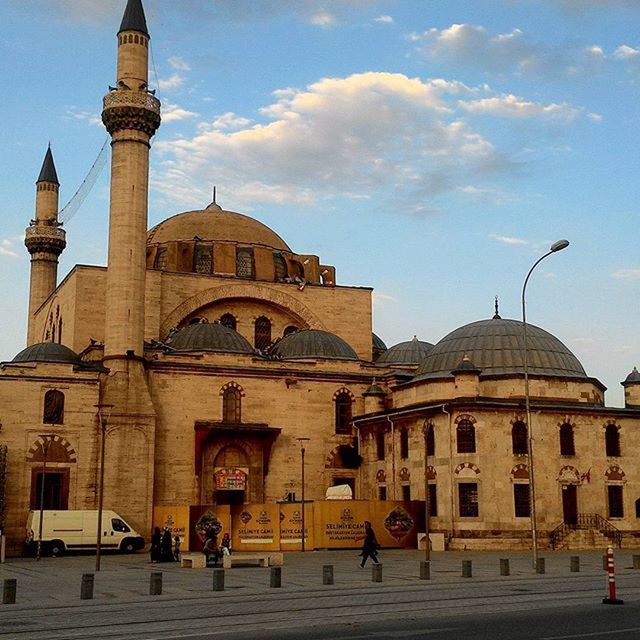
[416,24,604,75]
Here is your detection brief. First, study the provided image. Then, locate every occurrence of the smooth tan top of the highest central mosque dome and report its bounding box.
[147,204,291,252]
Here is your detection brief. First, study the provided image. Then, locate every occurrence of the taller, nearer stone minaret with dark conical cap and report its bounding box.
[102,0,160,373]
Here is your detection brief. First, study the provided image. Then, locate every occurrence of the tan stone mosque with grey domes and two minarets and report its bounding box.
[0,0,640,552]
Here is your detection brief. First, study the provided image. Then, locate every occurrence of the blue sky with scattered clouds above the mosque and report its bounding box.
[0,0,640,406]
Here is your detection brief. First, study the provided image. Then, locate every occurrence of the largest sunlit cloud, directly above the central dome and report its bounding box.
[154,72,512,210]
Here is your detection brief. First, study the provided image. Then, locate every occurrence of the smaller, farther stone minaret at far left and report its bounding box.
[24,147,67,346]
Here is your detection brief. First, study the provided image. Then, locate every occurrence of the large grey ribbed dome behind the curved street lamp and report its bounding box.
[415,317,587,379]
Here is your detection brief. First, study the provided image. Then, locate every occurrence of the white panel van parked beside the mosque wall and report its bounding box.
[27,509,144,556]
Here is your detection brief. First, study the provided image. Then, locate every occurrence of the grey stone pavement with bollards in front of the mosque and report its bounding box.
[0,550,640,640]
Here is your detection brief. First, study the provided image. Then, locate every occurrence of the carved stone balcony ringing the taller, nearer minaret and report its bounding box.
[102,89,160,136]
